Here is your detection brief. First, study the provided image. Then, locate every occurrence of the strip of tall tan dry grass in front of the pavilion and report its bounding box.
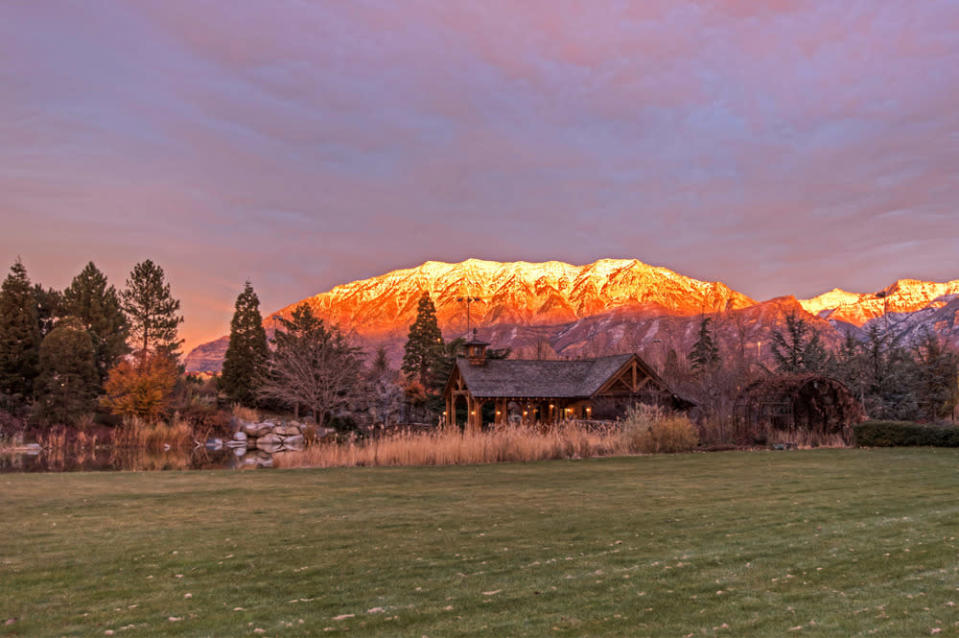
[274,407,698,467]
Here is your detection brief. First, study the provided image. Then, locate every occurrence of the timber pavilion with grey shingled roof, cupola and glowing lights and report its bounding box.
[444,335,693,429]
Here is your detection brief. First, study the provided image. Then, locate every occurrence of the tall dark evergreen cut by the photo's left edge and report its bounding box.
[0,259,41,407]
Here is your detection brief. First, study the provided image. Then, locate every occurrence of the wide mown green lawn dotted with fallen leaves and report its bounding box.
[0,449,959,638]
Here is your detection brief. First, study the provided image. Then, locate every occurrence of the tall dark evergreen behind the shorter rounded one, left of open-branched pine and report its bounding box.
[60,261,129,384]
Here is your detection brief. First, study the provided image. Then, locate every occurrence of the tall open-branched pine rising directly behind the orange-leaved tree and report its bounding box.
[120,259,183,358]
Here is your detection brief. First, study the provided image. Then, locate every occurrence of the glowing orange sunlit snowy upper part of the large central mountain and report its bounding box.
[279,259,755,336]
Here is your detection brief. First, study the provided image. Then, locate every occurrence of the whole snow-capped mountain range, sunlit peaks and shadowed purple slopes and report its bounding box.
[186,259,959,372]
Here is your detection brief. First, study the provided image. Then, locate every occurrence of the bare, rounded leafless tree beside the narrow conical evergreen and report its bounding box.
[260,303,363,425]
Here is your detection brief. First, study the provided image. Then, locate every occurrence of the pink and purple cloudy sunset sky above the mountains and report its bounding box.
[0,0,959,348]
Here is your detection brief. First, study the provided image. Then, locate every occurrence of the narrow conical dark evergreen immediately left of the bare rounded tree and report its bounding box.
[220,282,270,407]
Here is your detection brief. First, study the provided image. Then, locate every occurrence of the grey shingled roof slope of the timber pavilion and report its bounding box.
[456,354,633,399]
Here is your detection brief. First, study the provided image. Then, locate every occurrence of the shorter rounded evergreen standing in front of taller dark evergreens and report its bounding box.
[35,317,100,425]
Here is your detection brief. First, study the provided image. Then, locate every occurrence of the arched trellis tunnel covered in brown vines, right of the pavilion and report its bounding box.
[735,374,864,442]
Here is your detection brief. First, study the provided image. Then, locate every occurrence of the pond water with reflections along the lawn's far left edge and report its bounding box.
[0,446,273,473]
